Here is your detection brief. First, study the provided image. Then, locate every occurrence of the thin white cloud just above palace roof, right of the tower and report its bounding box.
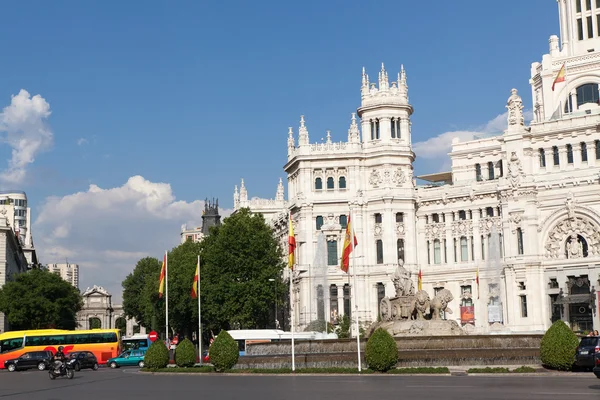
[413,111,533,170]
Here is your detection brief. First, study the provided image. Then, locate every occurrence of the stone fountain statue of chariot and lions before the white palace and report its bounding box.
[367,259,464,336]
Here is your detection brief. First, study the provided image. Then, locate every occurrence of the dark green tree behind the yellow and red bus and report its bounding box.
[0,269,83,330]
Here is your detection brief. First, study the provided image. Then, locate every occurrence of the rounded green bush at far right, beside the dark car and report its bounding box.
[540,321,579,371]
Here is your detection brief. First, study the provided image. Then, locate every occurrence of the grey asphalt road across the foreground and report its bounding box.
[0,368,600,400]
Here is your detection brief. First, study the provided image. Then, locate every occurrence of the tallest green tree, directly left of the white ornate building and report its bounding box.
[200,209,285,332]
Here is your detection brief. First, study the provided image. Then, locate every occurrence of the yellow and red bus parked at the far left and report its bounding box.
[0,329,121,369]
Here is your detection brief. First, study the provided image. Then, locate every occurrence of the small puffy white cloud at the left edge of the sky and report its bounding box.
[0,89,53,183]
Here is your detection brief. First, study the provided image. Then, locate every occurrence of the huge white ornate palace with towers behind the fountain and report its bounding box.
[234,0,600,333]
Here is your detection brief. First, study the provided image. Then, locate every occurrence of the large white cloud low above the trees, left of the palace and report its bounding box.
[32,176,231,301]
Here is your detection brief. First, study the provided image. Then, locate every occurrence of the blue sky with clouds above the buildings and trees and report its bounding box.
[0,0,559,298]
